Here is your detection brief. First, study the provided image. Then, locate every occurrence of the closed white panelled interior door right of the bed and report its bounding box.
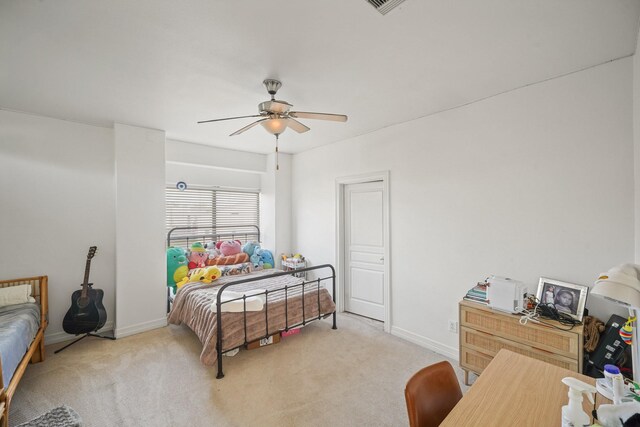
[344,181,386,321]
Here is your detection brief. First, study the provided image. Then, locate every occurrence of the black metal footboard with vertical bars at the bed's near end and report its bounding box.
[216,264,338,379]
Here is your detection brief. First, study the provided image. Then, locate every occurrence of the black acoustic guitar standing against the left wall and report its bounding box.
[62,246,107,335]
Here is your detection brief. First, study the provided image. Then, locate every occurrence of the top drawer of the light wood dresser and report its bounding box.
[460,305,581,362]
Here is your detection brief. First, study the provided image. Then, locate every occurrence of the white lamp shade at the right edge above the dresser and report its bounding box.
[591,264,640,308]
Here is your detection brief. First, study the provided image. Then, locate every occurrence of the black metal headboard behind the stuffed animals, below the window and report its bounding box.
[167,225,260,248]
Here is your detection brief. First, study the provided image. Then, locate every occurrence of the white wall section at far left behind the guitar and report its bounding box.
[0,110,115,344]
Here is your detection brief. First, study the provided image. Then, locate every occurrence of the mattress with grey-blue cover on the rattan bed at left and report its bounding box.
[0,303,40,386]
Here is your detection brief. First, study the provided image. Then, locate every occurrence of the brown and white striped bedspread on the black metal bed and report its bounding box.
[169,270,335,366]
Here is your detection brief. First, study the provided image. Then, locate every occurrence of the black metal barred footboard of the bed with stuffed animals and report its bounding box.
[216,264,338,379]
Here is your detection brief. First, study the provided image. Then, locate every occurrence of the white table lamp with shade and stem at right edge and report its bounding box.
[591,264,640,382]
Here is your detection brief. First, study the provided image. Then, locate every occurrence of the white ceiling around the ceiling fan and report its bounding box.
[0,0,640,153]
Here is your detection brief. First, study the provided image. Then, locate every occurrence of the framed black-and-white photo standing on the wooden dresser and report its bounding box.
[536,277,589,322]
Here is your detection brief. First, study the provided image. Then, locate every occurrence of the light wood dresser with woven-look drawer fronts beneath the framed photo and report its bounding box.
[460,301,584,385]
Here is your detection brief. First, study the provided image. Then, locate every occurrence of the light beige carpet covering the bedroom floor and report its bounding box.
[9,314,462,427]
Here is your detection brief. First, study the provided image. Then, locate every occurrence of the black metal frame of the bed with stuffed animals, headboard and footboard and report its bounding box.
[167,225,338,379]
